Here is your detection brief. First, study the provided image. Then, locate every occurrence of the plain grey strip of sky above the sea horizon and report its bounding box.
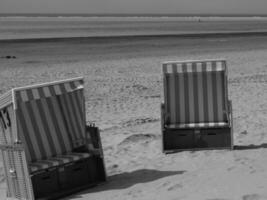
[0,0,267,14]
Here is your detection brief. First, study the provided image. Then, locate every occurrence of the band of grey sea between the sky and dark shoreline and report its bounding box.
[0,14,267,40]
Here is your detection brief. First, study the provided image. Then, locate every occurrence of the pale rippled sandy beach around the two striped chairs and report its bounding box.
[0,35,267,200]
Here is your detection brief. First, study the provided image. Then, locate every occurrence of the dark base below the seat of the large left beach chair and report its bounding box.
[31,156,106,200]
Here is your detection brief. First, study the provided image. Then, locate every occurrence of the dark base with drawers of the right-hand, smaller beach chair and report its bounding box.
[163,127,232,153]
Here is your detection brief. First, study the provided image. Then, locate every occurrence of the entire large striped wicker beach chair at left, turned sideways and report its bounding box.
[0,78,106,200]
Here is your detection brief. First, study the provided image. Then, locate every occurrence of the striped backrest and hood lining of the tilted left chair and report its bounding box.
[16,81,86,162]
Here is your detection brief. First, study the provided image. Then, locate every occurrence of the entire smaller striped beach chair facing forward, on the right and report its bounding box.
[161,60,233,153]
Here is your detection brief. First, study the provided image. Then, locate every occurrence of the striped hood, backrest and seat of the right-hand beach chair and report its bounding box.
[163,60,228,128]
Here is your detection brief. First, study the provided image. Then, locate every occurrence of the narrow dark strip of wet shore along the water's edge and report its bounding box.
[0,31,267,43]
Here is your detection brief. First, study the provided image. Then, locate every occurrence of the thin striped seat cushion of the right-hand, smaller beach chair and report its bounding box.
[166,122,228,128]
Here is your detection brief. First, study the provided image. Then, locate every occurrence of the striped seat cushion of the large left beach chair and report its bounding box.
[29,153,90,173]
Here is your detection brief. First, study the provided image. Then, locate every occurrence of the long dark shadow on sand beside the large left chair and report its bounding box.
[64,169,185,200]
